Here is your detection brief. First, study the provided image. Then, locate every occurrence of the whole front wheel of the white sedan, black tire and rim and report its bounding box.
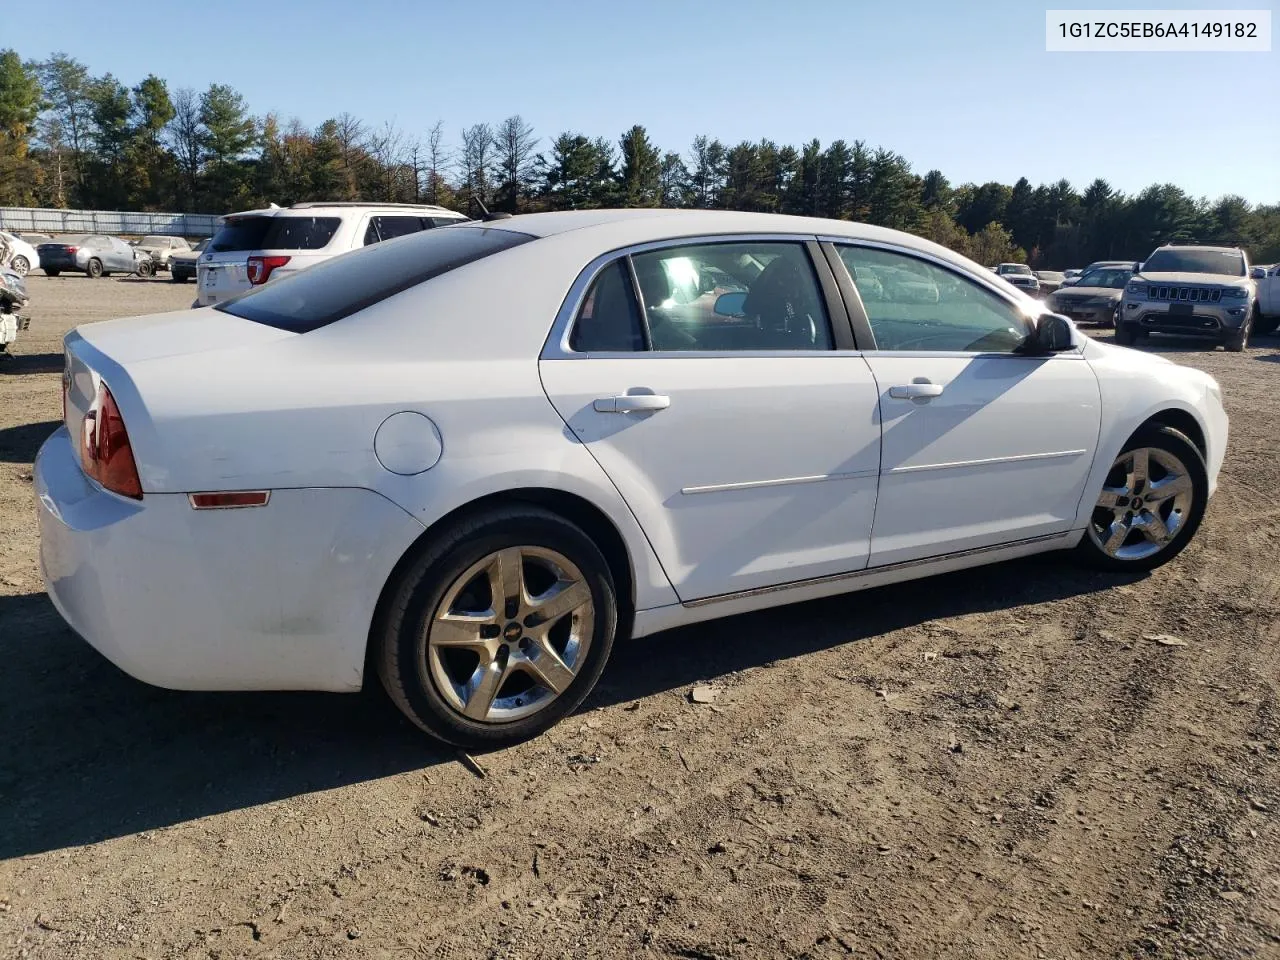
[1076,424,1208,571]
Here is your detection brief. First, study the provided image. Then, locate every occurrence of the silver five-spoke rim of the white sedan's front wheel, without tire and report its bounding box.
[1089,447,1196,561]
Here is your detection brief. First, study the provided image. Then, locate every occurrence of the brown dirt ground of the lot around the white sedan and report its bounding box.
[0,276,1280,960]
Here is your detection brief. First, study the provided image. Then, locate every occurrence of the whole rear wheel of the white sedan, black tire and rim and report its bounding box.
[374,506,617,750]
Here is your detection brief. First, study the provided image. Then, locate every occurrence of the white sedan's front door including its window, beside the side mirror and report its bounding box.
[840,246,1101,566]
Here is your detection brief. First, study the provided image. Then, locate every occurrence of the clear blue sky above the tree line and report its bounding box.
[0,0,1280,204]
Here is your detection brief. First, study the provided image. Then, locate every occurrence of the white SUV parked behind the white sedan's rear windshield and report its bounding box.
[192,202,467,307]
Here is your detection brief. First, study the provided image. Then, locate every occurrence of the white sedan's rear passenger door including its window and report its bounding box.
[541,241,879,600]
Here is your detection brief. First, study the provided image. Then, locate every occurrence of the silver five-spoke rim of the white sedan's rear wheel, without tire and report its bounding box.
[420,547,595,723]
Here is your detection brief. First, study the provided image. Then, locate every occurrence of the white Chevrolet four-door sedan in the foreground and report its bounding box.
[35,210,1228,748]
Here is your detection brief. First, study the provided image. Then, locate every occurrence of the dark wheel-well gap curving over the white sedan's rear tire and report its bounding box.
[364,486,636,690]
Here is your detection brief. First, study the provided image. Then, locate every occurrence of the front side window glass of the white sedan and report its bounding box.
[840,246,1030,353]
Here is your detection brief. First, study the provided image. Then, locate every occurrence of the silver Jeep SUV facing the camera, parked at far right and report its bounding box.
[1116,243,1257,352]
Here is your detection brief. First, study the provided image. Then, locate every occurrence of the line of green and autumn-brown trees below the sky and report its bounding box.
[0,50,1280,269]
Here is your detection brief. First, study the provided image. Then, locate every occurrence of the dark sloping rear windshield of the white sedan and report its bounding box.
[214,227,532,333]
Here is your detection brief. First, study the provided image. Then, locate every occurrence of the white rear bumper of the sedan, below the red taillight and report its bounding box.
[33,428,422,691]
